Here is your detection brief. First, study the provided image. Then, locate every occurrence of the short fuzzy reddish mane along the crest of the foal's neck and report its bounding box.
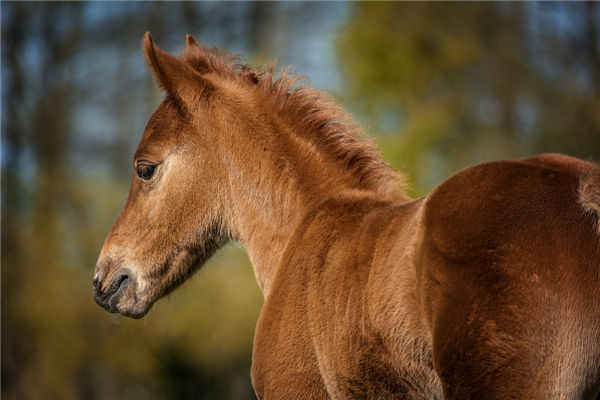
[182,46,405,194]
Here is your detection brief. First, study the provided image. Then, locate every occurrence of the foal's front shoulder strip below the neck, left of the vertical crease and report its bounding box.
[252,198,366,399]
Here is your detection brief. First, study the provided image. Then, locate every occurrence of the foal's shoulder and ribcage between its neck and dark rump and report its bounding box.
[253,195,435,398]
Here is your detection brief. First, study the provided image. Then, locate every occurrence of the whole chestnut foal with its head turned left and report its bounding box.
[93,34,600,399]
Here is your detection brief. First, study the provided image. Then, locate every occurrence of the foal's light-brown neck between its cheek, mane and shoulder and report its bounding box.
[221,111,366,298]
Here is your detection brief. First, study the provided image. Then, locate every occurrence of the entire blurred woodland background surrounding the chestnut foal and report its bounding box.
[0,2,600,399]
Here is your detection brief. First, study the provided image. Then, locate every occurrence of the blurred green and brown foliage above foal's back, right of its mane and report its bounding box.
[338,2,600,195]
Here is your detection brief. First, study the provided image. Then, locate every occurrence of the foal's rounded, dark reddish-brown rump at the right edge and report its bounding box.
[418,155,600,399]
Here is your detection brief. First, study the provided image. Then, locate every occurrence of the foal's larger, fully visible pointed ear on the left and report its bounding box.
[142,32,212,106]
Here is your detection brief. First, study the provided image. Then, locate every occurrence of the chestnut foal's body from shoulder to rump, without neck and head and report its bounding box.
[253,156,600,399]
